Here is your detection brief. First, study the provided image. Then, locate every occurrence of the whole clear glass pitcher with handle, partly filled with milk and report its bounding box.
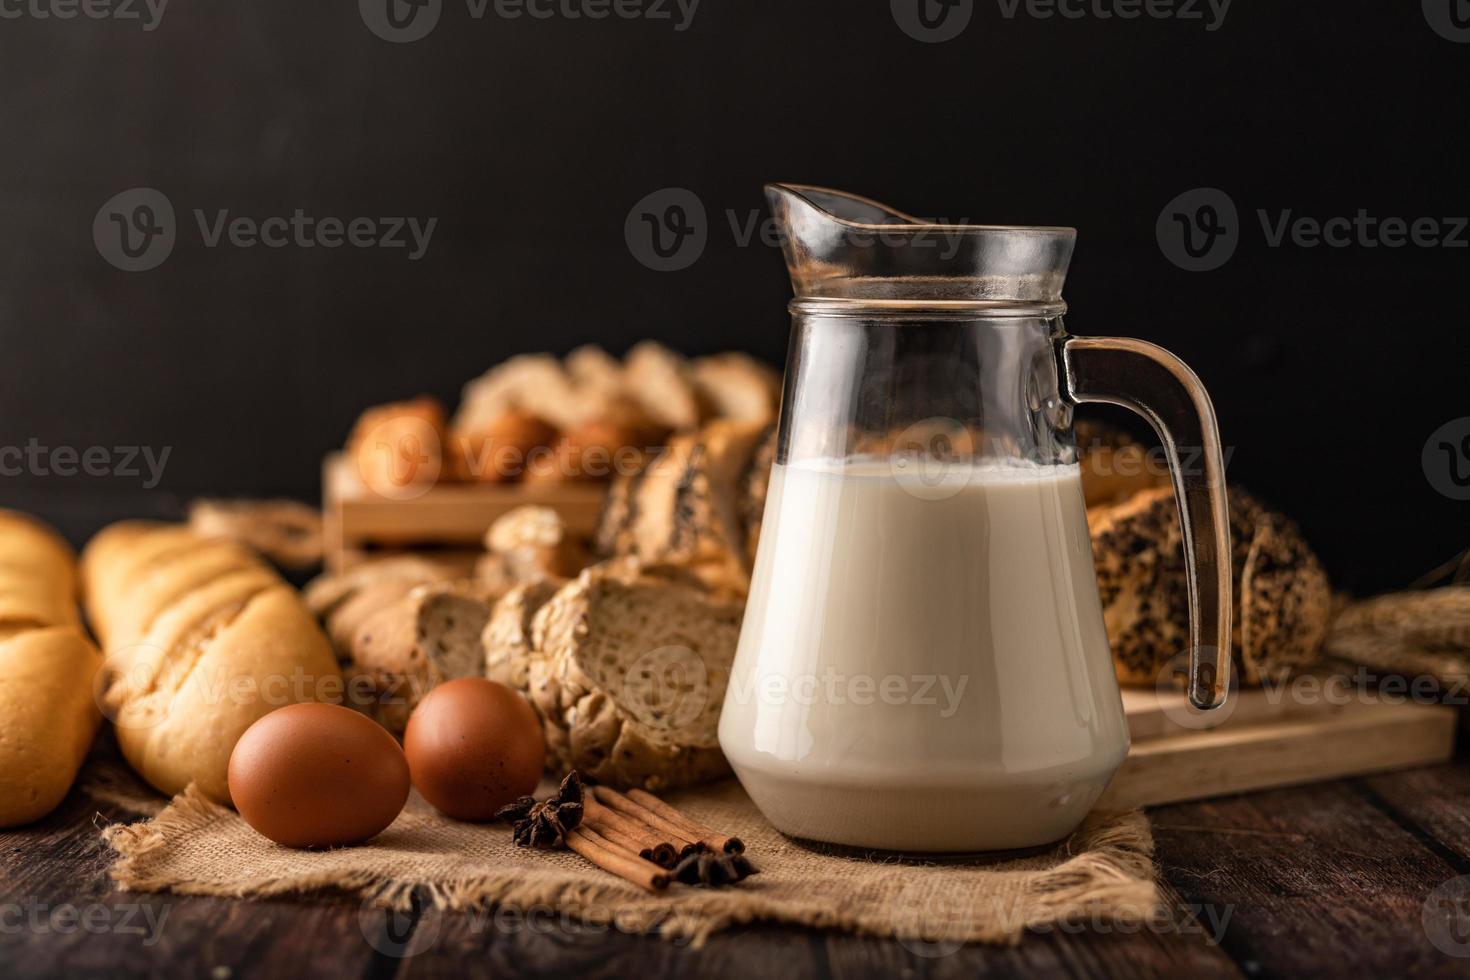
[719,184,1230,852]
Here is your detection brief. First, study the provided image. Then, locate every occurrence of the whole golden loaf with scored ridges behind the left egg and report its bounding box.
[82,522,343,804]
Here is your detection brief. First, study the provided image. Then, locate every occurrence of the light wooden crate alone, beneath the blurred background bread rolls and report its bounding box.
[322,453,607,572]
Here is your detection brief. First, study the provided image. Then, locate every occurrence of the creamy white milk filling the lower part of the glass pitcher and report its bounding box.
[720,458,1127,851]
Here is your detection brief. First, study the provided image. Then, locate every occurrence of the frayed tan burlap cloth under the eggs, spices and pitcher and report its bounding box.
[94,767,1158,943]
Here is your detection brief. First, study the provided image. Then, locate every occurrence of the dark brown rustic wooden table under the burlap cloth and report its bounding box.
[0,761,1470,980]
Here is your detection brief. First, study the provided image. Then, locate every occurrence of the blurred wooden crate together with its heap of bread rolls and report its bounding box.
[322,341,781,570]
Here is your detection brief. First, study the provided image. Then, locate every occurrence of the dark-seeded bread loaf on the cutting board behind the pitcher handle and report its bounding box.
[1088,486,1332,686]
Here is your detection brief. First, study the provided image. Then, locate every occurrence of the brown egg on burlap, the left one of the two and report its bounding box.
[229,704,409,848]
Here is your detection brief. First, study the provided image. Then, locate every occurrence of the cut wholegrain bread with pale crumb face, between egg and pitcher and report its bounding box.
[517,563,742,789]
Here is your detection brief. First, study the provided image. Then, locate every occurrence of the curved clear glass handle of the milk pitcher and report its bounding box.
[1060,336,1232,710]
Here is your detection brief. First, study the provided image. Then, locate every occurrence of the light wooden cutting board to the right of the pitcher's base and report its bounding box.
[1098,689,1457,807]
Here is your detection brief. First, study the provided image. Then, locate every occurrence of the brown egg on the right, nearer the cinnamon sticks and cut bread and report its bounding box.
[403,677,547,820]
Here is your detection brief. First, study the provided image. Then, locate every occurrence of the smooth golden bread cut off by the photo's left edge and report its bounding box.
[0,511,101,827]
